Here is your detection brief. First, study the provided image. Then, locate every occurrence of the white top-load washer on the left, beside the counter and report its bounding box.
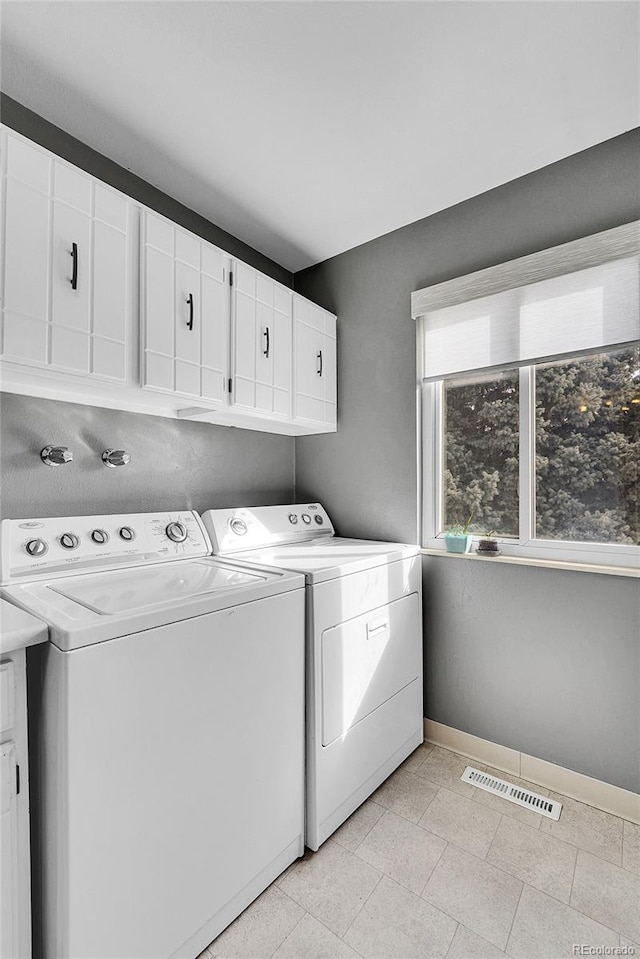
[0,512,304,959]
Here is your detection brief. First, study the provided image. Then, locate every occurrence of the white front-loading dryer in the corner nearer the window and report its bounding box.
[203,503,423,849]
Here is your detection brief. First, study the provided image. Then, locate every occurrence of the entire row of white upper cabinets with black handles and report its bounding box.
[0,125,336,436]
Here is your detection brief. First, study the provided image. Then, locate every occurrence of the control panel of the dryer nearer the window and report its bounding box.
[202,503,334,553]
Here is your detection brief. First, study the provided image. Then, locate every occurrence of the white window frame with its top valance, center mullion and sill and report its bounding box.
[411,221,640,571]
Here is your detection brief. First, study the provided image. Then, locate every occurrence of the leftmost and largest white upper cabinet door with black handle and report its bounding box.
[2,131,132,382]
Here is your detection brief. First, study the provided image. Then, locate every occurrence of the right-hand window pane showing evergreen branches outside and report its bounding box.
[535,349,640,546]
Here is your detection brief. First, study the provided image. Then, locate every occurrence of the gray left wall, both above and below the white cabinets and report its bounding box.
[0,95,294,519]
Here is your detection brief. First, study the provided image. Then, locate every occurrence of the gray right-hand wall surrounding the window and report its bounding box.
[294,130,640,790]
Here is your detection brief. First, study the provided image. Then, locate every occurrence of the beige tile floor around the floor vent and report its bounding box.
[200,744,640,959]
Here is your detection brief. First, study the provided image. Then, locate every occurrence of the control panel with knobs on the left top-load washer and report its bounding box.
[0,510,211,585]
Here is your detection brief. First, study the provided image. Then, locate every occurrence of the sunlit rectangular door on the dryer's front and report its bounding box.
[322,593,422,746]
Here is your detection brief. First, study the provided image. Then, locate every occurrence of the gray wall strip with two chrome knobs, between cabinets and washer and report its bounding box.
[0,393,294,519]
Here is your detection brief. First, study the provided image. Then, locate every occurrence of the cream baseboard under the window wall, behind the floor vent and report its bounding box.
[424,719,640,825]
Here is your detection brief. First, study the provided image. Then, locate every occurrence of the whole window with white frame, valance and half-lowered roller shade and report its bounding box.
[412,224,640,567]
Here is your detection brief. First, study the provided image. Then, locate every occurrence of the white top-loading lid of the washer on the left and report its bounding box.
[48,561,267,615]
